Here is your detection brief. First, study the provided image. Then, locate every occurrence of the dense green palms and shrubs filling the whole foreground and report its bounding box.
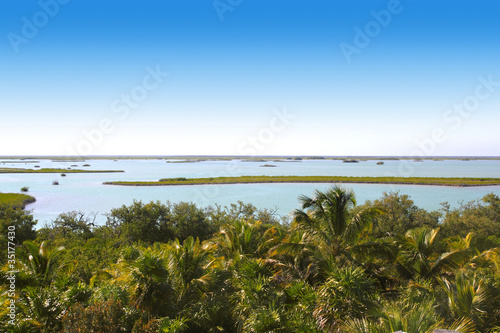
[0,186,500,333]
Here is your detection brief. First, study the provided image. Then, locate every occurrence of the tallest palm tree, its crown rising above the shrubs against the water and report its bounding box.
[272,186,384,281]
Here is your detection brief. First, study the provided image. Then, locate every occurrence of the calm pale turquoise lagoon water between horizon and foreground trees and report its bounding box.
[0,159,500,226]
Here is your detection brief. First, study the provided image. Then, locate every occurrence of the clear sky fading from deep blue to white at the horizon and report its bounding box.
[0,0,500,156]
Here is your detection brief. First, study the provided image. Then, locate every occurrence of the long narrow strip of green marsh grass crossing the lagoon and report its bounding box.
[104,176,500,187]
